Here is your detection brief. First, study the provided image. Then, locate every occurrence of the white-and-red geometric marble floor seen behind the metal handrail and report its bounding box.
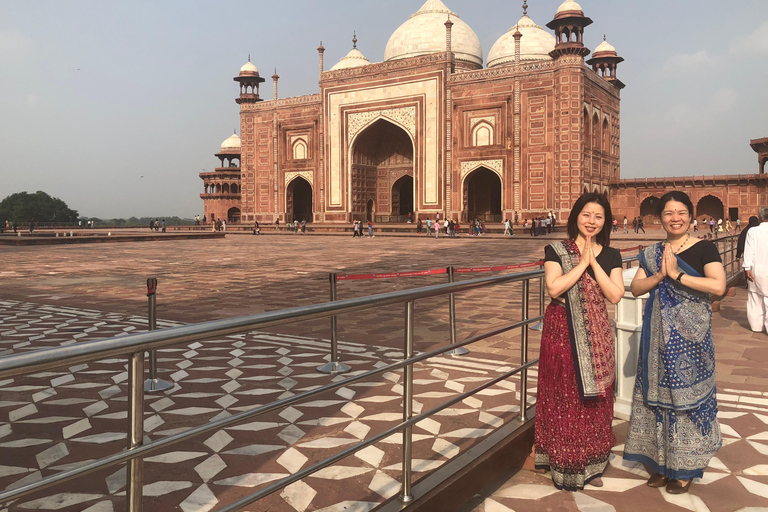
[0,301,536,512]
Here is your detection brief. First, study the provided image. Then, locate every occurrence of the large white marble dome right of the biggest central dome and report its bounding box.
[488,15,557,68]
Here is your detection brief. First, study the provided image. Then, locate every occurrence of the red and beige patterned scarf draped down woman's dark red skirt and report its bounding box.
[551,240,615,400]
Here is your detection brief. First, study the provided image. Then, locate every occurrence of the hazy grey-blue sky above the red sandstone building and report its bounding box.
[0,0,768,218]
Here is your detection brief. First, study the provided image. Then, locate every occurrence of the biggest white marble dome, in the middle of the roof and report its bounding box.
[384,0,483,67]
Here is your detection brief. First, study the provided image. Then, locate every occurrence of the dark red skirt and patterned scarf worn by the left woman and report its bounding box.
[535,241,616,491]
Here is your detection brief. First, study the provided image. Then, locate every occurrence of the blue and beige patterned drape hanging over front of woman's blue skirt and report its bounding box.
[638,243,715,412]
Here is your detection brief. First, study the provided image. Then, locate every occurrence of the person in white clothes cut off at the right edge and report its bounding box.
[742,208,768,332]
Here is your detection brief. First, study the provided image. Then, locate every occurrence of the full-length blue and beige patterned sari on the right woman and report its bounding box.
[624,243,722,480]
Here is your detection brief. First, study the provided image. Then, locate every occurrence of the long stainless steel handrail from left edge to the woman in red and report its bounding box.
[0,270,552,511]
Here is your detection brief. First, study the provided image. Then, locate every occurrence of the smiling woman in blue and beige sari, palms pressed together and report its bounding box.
[624,191,725,494]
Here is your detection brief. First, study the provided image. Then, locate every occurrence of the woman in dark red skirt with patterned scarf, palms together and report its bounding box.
[535,193,624,491]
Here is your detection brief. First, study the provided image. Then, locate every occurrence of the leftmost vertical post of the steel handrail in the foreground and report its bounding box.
[125,350,144,512]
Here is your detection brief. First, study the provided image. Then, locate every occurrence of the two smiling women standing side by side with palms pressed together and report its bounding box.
[535,191,728,494]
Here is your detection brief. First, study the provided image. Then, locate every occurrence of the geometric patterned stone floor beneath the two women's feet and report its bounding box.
[462,289,768,512]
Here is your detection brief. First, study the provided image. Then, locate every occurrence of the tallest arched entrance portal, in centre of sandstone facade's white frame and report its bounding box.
[350,119,414,222]
